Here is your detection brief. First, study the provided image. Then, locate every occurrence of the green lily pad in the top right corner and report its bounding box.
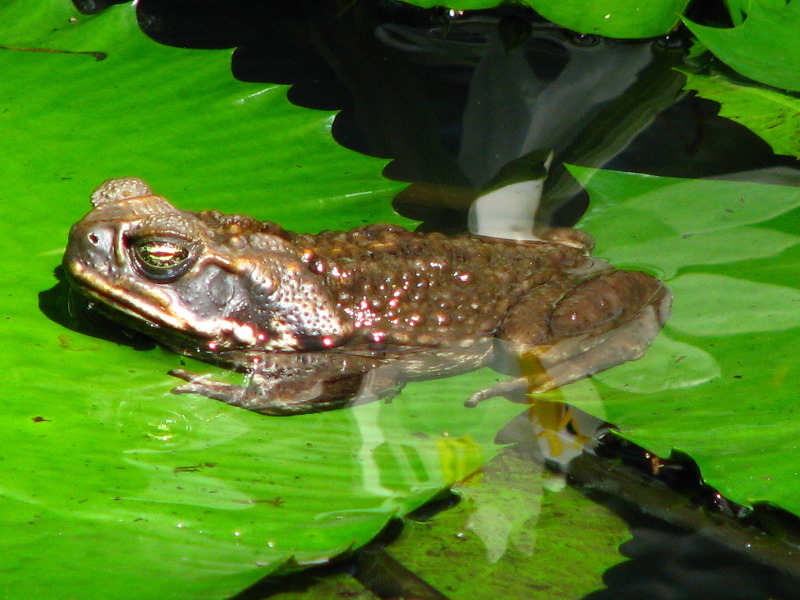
[684,0,800,91]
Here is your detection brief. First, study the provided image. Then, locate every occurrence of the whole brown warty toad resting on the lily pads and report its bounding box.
[63,178,670,415]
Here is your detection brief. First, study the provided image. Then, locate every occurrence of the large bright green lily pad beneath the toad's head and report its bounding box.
[0,0,519,599]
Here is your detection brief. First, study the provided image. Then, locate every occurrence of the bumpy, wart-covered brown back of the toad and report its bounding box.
[289,224,595,346]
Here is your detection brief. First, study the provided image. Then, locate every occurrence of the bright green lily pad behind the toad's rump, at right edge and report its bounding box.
[558,168,800,513]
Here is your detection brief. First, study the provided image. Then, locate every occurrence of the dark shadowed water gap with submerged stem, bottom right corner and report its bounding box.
[568,434,800,600]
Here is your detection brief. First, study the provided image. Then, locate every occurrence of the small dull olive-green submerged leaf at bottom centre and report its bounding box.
[388,451,629,600]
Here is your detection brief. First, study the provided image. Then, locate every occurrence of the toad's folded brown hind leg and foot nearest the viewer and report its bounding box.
[467,271,671,405]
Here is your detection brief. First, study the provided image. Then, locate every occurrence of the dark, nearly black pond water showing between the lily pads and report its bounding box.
[70,0,800,600]
